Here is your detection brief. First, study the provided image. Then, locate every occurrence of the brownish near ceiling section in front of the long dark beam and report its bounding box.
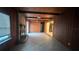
[19,7,65,13]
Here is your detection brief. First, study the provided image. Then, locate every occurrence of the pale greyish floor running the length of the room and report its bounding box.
[12,33,69,51]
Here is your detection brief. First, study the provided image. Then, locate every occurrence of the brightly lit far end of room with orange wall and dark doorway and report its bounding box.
[26,21,54,37]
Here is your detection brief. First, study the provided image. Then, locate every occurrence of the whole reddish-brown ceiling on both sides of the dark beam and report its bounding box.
[19,7,64,20]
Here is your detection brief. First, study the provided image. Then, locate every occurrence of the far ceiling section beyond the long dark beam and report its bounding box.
[25,13,54,20]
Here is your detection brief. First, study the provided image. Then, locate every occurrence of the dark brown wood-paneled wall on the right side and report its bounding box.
[54,8,79,50]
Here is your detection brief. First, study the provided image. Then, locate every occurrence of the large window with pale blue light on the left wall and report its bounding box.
[0,13,10,44]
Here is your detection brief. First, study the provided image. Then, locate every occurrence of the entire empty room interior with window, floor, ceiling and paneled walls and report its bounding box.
[0,7,79,51]
